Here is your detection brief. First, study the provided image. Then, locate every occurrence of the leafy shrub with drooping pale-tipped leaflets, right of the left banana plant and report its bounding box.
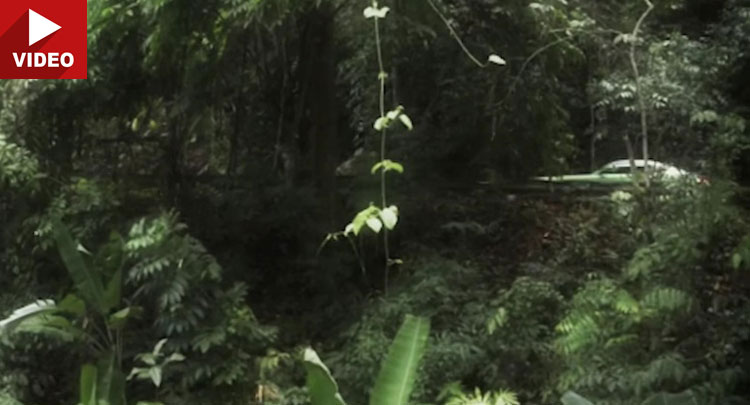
[124,214,276,402]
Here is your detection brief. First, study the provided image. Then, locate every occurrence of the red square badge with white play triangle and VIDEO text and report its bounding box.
[0,0,87,79]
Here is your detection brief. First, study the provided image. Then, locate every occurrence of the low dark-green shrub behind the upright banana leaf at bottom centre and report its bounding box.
[326,257,562,402]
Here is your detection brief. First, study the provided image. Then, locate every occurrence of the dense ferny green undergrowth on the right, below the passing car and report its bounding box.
[555,184,748,404]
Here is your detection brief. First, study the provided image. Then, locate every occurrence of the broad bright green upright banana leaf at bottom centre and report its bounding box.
[370,315,430,405]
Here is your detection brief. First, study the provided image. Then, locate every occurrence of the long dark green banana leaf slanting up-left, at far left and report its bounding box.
[52,218,106,314]
